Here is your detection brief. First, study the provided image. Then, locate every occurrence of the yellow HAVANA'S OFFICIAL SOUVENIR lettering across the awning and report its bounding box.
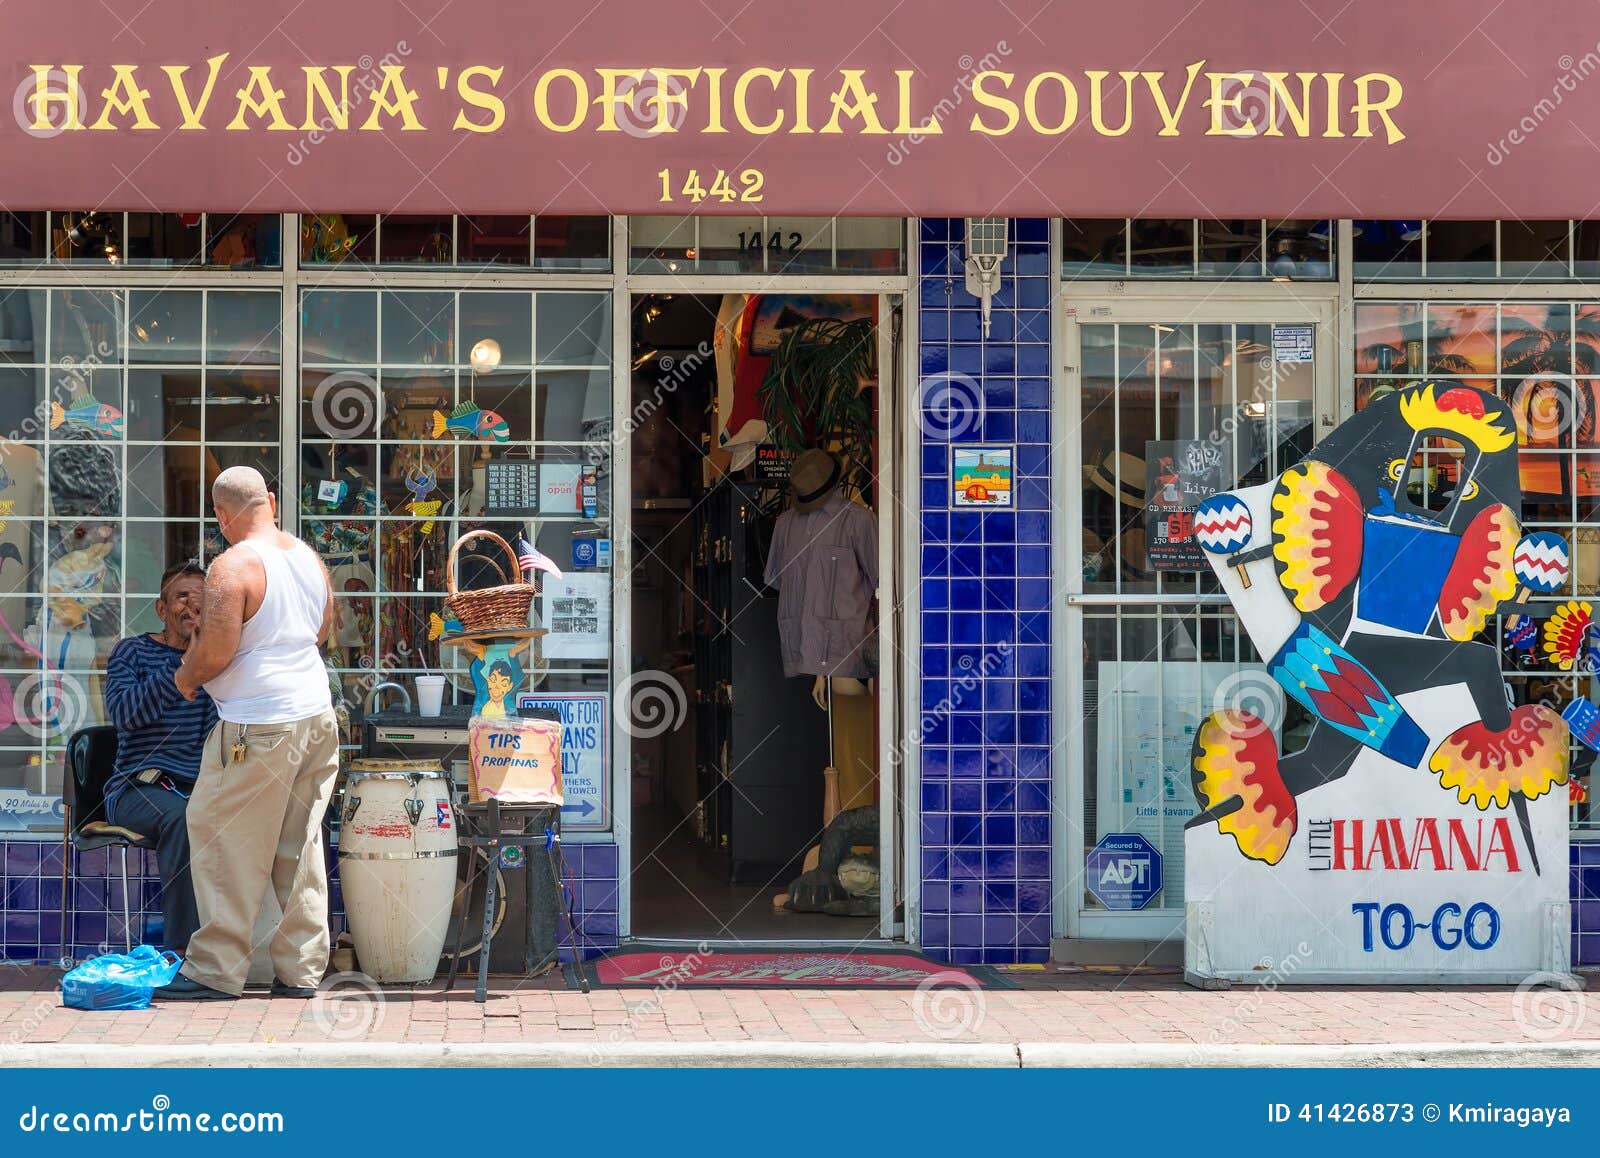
[14,59,1405,146]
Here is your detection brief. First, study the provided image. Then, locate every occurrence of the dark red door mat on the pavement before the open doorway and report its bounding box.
[568,948,1016,988]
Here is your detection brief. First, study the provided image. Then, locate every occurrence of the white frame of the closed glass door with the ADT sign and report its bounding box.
[1051,282,1346,940]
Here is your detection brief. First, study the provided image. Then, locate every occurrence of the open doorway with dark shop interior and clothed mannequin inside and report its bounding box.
[629,293,898,942]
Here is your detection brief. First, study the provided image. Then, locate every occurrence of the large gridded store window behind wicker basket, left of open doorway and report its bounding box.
[299,288,613,751]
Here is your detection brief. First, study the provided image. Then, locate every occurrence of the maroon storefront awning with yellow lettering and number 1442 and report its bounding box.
[0,0,1600,218]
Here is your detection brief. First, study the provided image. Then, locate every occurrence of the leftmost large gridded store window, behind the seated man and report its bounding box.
[0,288,282,799]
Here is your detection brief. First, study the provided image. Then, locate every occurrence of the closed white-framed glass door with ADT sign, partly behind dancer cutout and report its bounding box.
[1056,294,1336,939]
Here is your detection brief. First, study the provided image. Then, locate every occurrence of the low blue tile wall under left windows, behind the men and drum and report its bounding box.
[0,840,618,961]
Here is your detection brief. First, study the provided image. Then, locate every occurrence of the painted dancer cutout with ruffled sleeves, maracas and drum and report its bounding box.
[1189,382,1568,864]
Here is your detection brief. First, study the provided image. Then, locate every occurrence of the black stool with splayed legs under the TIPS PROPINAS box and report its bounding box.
[445,800,589,1004]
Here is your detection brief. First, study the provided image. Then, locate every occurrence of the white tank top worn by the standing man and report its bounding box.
[205,539,333,725]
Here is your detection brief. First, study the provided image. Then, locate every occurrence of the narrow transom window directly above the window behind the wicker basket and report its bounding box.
[299,213,611,274]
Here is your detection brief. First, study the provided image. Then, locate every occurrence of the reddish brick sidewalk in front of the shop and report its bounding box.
[0,966,1600,1060]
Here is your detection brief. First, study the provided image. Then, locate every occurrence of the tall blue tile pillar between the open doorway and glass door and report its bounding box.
[918,218,1051,964]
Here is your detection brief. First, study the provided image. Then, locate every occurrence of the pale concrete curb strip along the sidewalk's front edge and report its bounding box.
[9,1041,1600,1068]
